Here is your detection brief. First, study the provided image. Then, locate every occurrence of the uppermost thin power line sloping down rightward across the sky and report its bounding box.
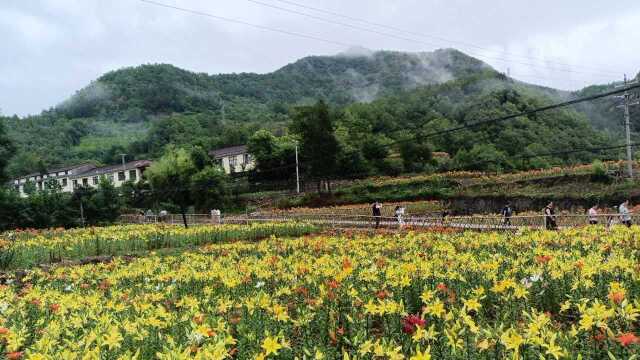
[258,0,618,76]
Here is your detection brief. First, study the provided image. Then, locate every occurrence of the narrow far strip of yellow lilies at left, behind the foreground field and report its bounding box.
[0,223,314,269]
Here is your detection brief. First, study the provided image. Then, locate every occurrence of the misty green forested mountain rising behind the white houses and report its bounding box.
[2,49,640,176]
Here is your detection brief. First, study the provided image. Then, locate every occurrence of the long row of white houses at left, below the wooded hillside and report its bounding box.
[12,160,151,197]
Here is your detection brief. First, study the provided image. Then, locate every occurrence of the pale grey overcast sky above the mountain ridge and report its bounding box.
[0,0,640,115]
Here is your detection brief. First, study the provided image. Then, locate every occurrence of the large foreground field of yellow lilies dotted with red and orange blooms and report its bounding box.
[0,227,640,359]
